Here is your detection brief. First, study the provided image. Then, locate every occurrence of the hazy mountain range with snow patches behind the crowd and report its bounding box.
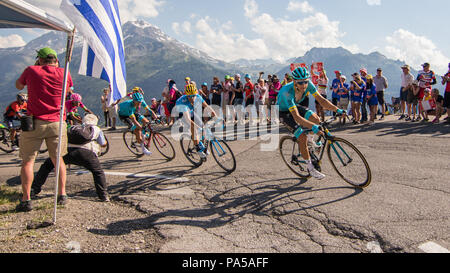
[0,21,424,116]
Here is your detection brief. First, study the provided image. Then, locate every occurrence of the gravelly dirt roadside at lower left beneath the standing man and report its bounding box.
[0,177,164,253]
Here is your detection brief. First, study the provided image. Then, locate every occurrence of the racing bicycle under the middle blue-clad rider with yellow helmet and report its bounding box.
[180,118,236,173]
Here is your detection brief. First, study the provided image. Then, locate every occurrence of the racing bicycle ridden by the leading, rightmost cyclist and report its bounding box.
[279,113,372,188]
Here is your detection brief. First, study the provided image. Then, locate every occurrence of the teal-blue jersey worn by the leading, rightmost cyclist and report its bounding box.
[278,81,319,112]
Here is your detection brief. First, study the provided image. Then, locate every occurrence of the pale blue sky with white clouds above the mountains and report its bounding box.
[0,0,450,73]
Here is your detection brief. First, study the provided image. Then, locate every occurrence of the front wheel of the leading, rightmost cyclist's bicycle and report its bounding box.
[327,137,372,188]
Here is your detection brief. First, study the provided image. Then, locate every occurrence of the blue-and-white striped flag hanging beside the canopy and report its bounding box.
[60,0,127,105]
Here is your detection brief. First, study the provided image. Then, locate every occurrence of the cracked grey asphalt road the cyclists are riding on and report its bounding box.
[0,113,450,253]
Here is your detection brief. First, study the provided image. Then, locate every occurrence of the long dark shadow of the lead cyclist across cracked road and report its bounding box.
[89,178,362,236]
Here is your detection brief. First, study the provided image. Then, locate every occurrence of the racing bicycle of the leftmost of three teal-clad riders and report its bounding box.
[123,119,175,161]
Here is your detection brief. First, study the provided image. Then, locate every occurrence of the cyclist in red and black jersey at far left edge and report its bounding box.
[3,93,28,151]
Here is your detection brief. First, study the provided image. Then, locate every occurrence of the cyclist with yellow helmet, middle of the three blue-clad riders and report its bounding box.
[174,84,217,158]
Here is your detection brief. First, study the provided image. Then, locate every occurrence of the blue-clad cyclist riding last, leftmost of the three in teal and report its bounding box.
[118,92,157,155]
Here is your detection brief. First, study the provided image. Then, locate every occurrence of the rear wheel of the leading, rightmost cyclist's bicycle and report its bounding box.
[279,136,310,178]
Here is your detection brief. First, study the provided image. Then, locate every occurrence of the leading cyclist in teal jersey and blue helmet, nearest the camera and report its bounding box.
[278,67,346,179]
